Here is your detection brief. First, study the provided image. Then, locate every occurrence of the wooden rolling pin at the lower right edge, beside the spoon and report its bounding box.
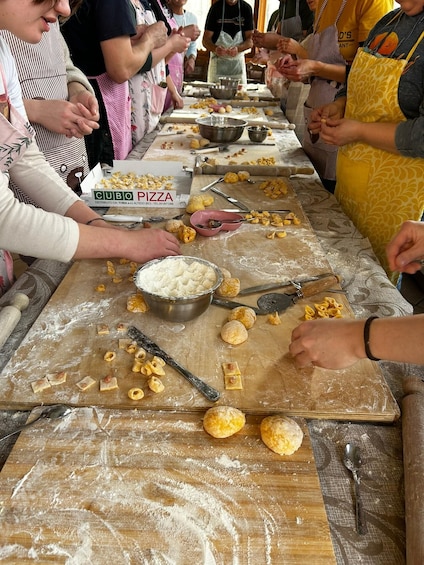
[402,377,424,565]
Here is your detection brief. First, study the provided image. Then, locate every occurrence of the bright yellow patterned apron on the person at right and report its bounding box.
[335,32,424,283]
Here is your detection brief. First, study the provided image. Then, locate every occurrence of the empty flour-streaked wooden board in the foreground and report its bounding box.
[0,408,335,565]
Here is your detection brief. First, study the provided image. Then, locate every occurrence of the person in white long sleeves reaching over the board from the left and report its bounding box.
[0,0,180,294]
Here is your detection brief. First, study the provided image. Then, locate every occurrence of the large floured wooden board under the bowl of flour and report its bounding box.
[0,177,399,422]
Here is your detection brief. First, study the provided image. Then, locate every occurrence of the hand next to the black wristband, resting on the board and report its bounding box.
[289,318,366,369]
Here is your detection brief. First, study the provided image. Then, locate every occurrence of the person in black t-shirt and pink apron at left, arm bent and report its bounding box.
[62,0,167,168]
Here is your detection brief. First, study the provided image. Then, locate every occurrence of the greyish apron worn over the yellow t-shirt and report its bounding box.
[302,0,347,180]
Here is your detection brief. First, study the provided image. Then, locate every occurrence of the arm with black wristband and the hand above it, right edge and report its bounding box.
[289,220,424,369]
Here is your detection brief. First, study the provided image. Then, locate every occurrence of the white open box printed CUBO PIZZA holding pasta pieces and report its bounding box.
[81,160,191,208]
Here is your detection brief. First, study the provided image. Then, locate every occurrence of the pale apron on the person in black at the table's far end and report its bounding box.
[208,0,247,84]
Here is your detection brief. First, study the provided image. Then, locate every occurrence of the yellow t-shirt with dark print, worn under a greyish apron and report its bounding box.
[315,0,393,64]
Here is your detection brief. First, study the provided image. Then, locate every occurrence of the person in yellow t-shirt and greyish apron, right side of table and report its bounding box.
[276,0,393,192]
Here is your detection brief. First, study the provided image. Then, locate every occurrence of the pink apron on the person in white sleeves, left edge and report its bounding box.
[0,66,34,296]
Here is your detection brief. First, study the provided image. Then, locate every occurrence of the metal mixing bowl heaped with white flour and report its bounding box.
[134,255,223,322]
